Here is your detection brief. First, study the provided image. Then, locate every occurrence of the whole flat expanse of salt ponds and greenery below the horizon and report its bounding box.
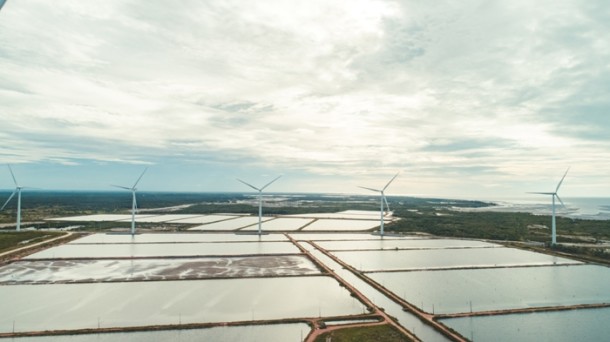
[0,192,610,342]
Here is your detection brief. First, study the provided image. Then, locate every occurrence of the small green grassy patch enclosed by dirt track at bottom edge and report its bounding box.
[315,324,412,342]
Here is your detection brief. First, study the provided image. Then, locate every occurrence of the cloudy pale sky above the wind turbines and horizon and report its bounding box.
[0,0,610,199]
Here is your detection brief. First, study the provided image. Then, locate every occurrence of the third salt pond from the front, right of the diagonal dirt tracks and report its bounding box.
[332,247,579,271]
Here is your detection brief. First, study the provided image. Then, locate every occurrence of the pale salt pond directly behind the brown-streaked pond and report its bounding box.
[25,242,301,259]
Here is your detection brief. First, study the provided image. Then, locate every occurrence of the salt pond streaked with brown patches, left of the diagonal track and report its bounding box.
[0,255,320,285]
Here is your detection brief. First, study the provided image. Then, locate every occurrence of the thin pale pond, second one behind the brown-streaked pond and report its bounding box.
[70,233,288,244]
